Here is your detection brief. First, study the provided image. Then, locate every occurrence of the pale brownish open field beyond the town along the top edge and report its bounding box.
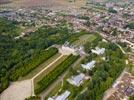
[1,0,86,9]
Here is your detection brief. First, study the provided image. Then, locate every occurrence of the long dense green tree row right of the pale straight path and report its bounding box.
[35,55,79,94]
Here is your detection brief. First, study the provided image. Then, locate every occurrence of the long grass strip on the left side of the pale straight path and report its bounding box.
[19,53,61,80]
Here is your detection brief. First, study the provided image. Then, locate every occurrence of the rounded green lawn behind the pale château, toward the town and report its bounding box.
[73,34,96,46]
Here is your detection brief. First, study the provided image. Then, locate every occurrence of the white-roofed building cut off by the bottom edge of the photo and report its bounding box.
[48,91,70,100]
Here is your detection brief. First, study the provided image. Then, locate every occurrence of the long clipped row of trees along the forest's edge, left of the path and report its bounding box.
[10,48,58,80]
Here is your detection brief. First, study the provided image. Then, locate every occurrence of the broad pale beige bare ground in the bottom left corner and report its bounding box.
[0,80,32,100]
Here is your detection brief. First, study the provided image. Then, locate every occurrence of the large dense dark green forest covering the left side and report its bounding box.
[0,18,83,93]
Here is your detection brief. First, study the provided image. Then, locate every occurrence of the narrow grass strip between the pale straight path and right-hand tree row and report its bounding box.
[34,56,68,87]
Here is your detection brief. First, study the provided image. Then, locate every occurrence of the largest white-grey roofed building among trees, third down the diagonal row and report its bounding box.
[67,73,85,87]
